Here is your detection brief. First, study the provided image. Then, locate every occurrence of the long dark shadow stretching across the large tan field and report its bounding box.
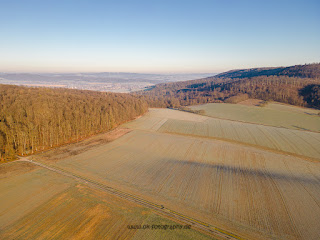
[169,160,320,185]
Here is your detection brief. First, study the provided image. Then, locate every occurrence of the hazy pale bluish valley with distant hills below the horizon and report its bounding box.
[0,72,215,92]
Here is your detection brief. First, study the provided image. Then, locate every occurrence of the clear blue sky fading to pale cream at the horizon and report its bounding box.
[0,0,320,73]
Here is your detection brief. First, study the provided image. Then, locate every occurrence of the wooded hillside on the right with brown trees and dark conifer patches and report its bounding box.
[138,64,320,108]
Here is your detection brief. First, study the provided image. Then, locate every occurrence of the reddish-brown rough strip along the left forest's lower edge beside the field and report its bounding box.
[29,128,132,162]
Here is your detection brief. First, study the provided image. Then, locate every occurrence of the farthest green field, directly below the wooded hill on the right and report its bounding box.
[190,99,320,132]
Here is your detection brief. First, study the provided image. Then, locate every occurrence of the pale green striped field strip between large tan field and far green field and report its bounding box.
[158,118,320,160]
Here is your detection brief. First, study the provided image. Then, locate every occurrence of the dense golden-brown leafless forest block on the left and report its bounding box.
[0,85,148,160]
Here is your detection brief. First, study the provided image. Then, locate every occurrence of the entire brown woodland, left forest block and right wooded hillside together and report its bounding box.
[0,64,320,161]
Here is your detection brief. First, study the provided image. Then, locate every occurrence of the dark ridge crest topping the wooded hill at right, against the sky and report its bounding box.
[216,63,320,78]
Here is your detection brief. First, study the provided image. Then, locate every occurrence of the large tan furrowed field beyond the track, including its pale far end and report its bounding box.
[30,109,320,239]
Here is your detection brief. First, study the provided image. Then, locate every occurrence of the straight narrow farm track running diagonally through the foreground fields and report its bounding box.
[17,158,244,240]
